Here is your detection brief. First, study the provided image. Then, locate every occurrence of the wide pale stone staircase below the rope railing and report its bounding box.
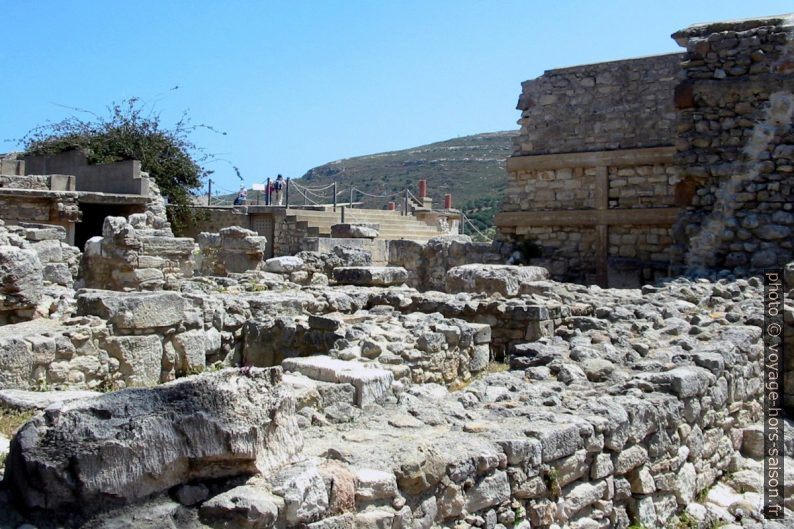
[285,208,441,242]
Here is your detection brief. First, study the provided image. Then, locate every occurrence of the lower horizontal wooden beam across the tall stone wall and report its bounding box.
[494,208,681,227]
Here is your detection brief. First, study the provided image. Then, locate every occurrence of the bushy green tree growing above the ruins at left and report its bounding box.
[20,97,235,230]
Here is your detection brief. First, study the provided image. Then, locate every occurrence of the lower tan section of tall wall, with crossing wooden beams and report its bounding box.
[495,145,678,286]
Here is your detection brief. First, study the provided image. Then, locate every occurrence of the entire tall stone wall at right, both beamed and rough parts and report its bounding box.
[496,11,794,287]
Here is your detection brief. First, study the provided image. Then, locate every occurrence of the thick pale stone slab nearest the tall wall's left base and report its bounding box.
[445,264,549,297]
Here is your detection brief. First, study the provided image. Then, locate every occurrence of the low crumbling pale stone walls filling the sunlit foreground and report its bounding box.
[0,10,794,529]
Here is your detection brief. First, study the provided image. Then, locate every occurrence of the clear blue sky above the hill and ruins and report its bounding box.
[0,0,792,195]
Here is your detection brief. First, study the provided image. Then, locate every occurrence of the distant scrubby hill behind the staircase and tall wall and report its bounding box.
[290,132,517,229]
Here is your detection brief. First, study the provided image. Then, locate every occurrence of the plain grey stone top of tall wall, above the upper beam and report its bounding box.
[513,54,681,156]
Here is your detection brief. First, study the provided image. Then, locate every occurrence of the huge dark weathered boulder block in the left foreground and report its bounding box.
[5,369,302,514]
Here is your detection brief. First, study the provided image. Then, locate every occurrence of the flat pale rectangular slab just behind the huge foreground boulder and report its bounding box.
[281,355,394,407]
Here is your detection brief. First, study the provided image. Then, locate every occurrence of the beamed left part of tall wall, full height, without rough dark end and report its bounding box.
[496,54,682,286]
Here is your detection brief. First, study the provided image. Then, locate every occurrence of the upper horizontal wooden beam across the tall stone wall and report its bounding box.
[507,146,675,172]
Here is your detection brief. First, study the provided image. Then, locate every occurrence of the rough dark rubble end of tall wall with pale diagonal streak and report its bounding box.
[673,17,794,275]
